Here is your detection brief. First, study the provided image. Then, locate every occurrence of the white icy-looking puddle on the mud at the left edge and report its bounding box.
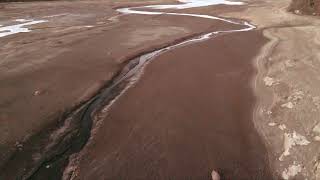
[0,19,47,37]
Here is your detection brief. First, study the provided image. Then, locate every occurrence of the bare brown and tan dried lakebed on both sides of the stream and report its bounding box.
[0,0,320,180]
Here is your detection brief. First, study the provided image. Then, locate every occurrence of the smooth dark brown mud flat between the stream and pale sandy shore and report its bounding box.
[74,31,273,180]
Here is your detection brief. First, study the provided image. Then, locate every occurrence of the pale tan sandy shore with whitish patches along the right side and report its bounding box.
[225,0,320,179]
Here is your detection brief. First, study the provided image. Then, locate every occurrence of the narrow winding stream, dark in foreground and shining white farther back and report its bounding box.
[10,0,256,179]
